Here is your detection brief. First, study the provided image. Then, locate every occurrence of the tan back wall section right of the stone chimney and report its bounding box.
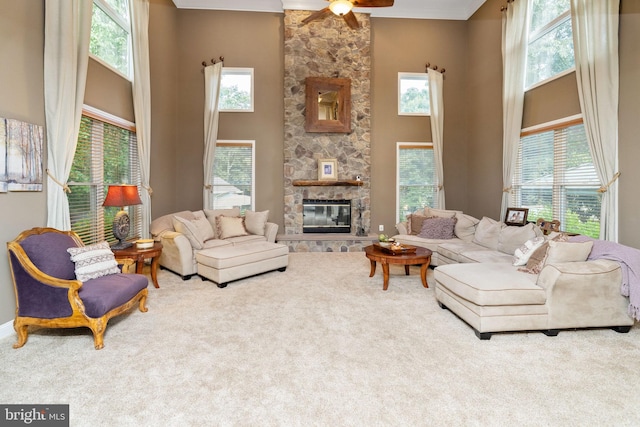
[371,18,468,234]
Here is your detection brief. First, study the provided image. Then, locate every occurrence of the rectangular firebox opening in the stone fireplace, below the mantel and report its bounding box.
[302,199,351,233]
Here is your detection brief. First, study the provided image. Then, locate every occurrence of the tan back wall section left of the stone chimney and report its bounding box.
[175,10,284,226]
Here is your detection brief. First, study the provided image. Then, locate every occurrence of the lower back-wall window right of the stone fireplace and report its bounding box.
[396,142,438,222]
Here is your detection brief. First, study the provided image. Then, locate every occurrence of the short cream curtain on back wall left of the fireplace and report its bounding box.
[202,62,223,209]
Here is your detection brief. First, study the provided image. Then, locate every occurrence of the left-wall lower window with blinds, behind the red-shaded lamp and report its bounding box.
[67,108,142,244]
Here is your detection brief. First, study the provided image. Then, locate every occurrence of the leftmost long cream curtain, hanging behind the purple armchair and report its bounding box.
[44,0,93,230]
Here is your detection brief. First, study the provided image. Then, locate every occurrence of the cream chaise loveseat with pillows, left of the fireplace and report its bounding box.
[150,208,289,287]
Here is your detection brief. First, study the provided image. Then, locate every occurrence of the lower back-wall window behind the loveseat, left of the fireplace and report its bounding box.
[212,141,255,212]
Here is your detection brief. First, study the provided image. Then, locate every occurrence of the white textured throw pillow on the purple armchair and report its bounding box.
[67,242,120,282]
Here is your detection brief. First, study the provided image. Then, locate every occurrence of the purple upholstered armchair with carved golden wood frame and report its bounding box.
[7,228,148,350]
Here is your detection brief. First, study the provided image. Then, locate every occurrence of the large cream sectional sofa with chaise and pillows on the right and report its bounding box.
[394,208,634,339]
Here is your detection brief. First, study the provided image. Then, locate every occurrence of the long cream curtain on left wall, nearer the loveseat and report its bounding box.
[129,0,153,237]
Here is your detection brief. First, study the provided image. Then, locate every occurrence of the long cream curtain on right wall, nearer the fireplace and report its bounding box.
[500,0,529,218]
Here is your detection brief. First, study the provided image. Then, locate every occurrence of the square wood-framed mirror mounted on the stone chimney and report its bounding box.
[305,77,351,133]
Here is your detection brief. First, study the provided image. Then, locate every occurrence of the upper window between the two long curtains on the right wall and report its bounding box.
[525,0,575,88]
